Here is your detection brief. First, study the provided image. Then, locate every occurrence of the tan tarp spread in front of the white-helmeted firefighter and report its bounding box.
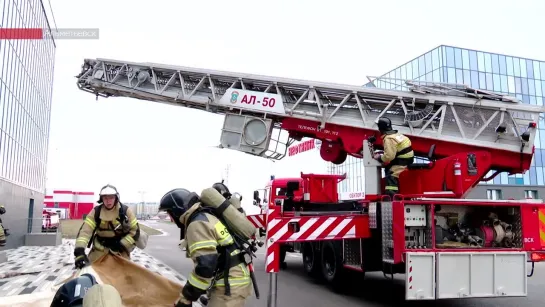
[0,254,182,307]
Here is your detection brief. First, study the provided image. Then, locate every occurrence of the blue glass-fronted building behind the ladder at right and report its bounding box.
[330,46,545,198]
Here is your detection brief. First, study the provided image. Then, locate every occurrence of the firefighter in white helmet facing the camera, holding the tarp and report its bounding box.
[74,185,140,268]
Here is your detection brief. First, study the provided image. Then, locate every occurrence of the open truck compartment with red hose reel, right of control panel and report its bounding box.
[434,205,522,248]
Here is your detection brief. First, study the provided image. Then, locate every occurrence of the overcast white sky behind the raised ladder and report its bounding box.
[42,0,545,214]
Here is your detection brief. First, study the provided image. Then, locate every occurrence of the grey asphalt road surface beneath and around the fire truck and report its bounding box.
[144,221,545,307]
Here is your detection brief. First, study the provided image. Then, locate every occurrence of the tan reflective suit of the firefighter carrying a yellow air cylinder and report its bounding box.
[180,204,251,293]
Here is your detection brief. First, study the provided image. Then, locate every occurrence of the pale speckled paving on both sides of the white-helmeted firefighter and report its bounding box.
[0,239,185,297]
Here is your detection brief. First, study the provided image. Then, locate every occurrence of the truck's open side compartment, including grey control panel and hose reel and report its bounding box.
[404,204,522,249]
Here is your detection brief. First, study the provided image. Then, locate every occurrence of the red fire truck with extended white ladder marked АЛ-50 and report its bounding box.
[77,59,545,306]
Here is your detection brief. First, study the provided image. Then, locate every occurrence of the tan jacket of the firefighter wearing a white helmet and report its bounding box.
[75,203,140,253]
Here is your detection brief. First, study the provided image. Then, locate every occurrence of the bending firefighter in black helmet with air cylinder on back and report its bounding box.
[159,188,252,307]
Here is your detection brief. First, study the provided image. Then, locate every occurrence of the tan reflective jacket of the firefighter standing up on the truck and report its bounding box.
[380,131,414,176]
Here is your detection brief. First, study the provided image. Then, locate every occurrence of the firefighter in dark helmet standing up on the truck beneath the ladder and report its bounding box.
[374,117,414,198]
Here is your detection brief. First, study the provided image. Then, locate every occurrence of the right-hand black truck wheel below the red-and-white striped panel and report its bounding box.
[321,241,346,291]
